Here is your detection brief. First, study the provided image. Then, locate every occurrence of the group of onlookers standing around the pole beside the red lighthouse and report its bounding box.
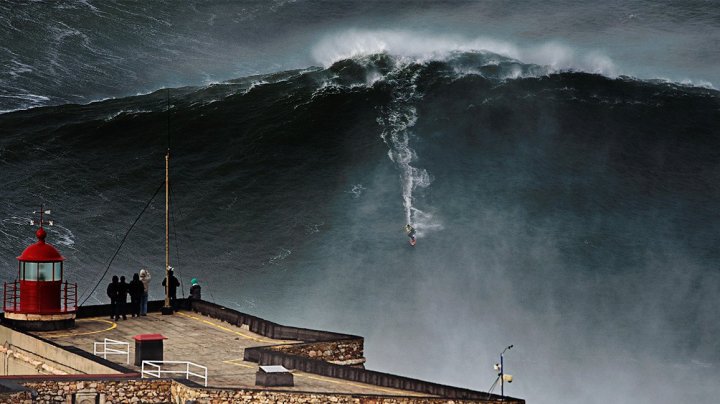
[107,268,201,320]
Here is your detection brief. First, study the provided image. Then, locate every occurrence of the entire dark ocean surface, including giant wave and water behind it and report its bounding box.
[0,2,720,403]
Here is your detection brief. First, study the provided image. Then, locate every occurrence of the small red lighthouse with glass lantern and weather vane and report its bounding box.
[3,209,77,331]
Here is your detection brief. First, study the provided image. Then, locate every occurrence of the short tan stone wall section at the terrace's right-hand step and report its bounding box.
[268,338,365,365]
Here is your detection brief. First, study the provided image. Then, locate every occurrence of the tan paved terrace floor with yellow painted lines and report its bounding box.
[33,311,431,397]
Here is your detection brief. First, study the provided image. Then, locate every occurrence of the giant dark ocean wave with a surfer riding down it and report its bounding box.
[0,49,720,402]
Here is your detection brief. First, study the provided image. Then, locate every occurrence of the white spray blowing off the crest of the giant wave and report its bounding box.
[312,29,618,77]
